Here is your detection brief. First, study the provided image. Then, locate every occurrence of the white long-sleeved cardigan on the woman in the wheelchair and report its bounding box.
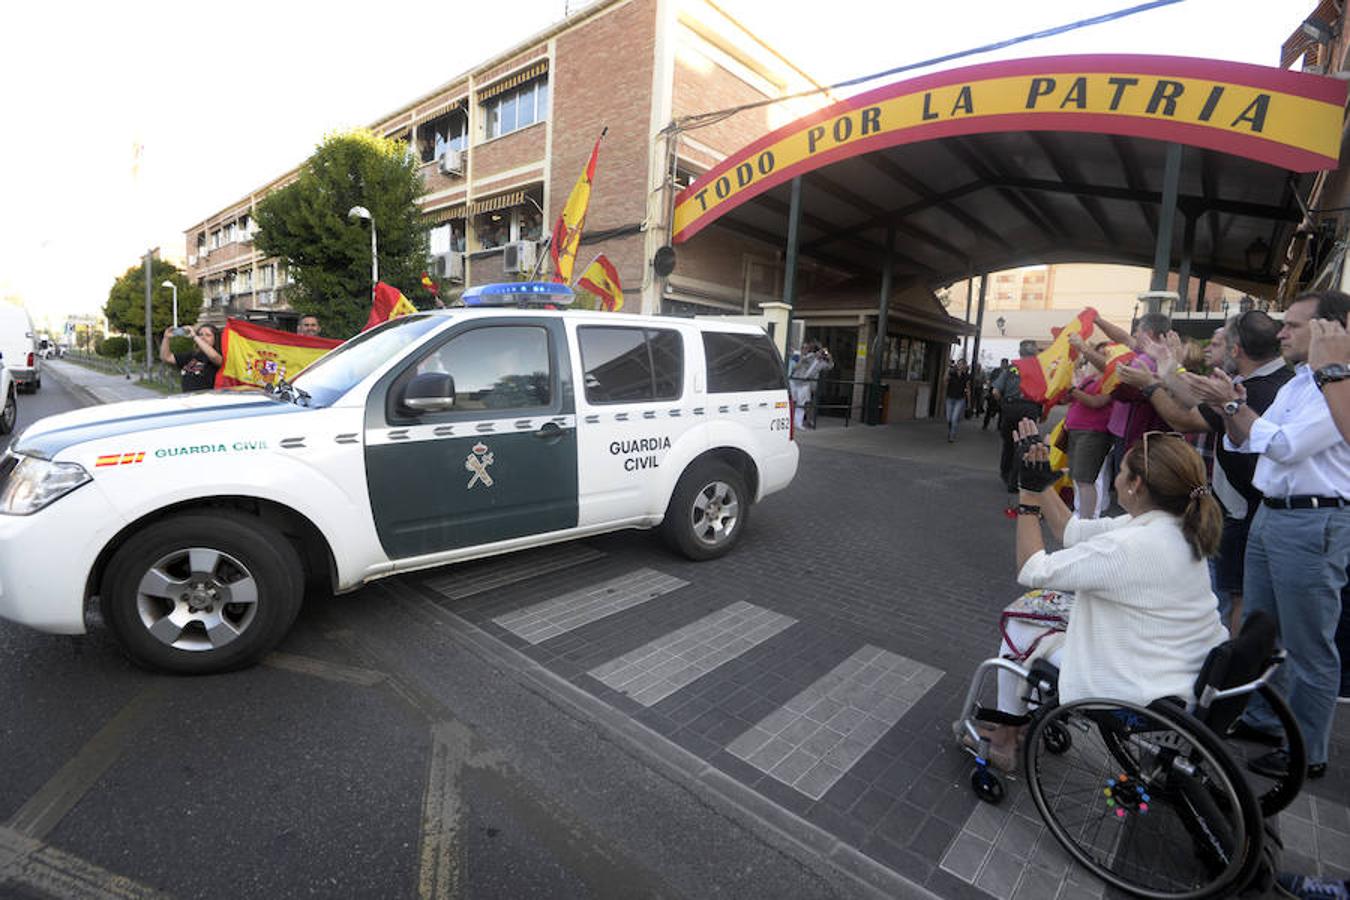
[1018,510,1229,704]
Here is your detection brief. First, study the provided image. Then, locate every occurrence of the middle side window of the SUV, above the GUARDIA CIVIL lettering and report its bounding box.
[576,325,684,403]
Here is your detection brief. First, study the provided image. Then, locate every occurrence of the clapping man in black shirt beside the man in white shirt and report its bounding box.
[1118,309,1293,634]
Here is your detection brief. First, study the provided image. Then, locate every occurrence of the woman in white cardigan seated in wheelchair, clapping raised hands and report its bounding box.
[990,418,1227,770]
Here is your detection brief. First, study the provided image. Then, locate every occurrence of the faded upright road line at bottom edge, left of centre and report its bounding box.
[417,722,474,900]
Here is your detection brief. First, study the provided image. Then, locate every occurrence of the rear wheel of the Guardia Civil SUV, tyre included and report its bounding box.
[662,460,751,560]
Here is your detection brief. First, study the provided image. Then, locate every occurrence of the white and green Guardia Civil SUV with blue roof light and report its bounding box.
[0,283,798,672]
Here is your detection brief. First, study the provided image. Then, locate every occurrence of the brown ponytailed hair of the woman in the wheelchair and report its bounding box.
[1126,432,1223,560]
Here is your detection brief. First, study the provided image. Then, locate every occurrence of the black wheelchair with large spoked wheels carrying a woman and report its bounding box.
[953,614,1307,897]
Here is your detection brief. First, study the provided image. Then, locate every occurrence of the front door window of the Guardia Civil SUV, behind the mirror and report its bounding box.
[417,325,554,412]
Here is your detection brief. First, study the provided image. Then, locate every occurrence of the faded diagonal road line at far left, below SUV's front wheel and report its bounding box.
[8,680,165,839]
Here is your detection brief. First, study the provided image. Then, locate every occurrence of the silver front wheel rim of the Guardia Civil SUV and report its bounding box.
[136,546,258,652]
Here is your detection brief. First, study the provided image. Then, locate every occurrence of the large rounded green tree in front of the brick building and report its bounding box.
[255,131,427,337]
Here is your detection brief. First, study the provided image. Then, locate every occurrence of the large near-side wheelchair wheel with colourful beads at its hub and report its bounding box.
[1022,700,1264,899]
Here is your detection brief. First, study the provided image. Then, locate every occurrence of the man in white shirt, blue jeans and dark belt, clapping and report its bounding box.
[1185,291,1350,779]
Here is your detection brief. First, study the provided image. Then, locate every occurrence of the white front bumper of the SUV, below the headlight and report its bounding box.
[0,484,117,634]
